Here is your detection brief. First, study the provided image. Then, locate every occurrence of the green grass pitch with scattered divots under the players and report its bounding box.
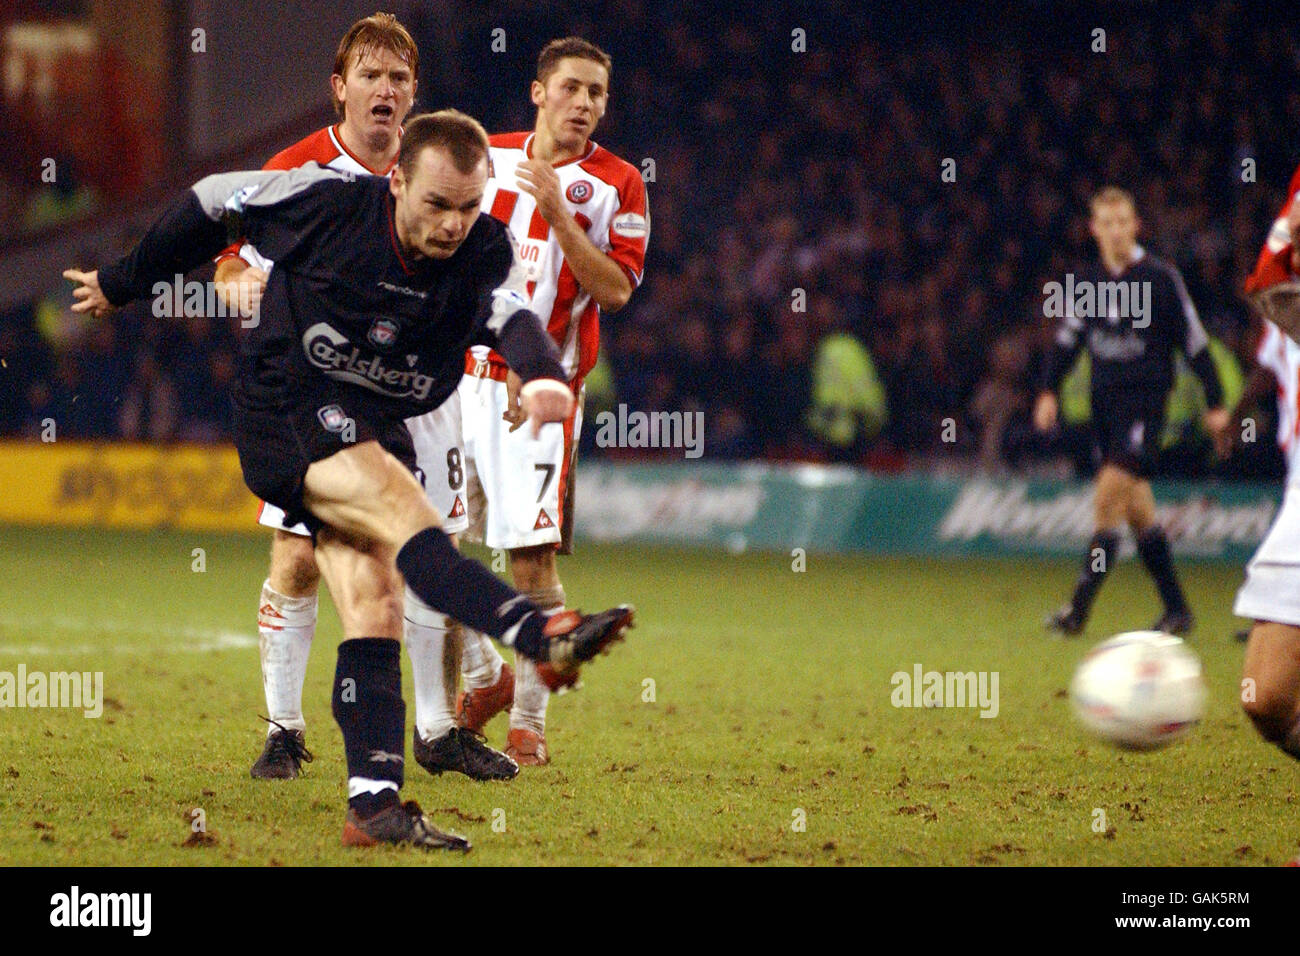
[0,529,1300,866]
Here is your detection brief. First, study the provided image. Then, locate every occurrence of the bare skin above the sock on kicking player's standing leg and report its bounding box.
[316,525,403,639]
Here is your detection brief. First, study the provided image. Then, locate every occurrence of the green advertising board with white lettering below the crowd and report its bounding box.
[576,462,1282,563]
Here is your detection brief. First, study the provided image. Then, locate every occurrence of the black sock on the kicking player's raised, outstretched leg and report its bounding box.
[398,528,547,658]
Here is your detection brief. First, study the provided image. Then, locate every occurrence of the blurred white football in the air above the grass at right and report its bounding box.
[1070,631,1205,750]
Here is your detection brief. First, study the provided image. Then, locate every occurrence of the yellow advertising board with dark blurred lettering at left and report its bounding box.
[0,441,259,531]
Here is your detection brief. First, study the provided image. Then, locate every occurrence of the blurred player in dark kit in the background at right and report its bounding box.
[1034,186,1229,635]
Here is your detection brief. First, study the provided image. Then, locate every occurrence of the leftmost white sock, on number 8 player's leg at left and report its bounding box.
[257,580,316,736]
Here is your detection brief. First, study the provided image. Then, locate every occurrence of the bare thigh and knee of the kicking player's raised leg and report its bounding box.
[303,441,442,548]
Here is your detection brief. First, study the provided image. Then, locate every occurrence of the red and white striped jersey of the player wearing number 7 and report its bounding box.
[467,133,650,381]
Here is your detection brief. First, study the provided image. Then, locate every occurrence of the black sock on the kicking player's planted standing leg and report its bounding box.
[332,637,406,817]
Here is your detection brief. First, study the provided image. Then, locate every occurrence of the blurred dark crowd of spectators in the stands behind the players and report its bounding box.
[0,0,1300,475]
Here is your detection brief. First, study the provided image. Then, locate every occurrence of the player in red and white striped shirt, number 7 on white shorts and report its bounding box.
[458,36,650,765]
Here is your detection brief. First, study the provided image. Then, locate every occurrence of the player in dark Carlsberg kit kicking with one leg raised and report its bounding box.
[64,111,632,849]
